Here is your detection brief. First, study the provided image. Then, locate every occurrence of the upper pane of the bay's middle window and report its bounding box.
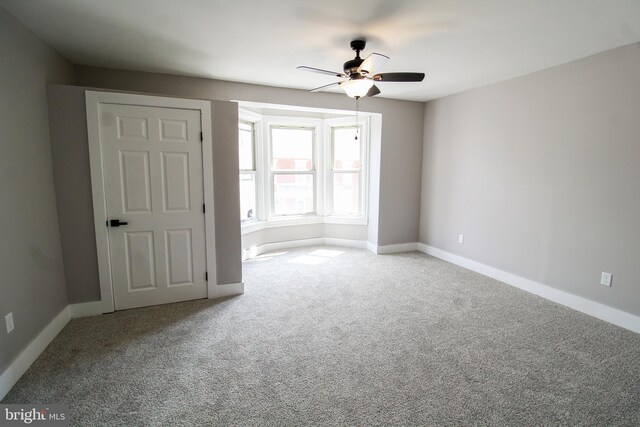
[271,128,313,170]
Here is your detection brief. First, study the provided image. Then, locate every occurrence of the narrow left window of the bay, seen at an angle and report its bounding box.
[238,122,257,222]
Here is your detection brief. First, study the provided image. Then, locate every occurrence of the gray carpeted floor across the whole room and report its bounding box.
[3,247,640,426]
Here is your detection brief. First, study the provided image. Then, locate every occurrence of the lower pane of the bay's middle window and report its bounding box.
[273,174,313,215]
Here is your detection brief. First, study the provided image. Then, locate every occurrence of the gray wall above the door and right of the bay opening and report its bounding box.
[76,66,424,245]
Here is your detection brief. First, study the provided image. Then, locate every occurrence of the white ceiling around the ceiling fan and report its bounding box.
[0,0,640,101]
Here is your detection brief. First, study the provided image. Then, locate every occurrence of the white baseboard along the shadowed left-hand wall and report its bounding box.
[0,306,71,400]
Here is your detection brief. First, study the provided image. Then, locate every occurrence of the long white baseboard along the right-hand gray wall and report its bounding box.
[418,243,640,333]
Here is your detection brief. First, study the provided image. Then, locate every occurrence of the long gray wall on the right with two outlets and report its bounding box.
[420,44,640,315]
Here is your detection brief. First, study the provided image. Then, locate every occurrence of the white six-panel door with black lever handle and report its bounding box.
[98,104,207,310]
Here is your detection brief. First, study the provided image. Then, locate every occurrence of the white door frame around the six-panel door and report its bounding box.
[85,91,217,313]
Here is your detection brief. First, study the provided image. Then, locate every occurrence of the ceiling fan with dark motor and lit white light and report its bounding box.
[298,40,424,99]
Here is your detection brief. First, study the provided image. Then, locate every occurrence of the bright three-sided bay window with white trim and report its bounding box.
[239,108,370,233]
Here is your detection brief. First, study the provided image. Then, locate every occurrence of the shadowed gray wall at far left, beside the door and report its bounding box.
[0,8,74,372]
